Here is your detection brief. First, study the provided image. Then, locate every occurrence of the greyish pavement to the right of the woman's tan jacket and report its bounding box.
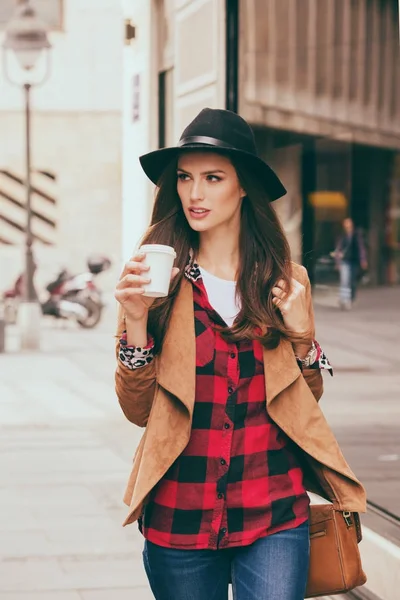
[315,287,400,526]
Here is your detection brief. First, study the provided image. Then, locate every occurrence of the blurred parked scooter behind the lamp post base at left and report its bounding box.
[3,256,111,329]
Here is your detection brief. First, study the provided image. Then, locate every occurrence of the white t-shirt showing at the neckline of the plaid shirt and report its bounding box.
[199,267,240,327]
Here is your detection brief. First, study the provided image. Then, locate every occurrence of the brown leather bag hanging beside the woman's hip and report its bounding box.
[306,504,367,598]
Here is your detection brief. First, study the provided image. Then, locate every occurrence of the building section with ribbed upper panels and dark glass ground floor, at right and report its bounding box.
[239,0,400,283]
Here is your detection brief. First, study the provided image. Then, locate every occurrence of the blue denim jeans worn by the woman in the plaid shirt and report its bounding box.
[143,522,310,600]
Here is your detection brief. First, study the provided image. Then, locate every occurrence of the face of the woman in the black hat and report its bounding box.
[177,152,245,232]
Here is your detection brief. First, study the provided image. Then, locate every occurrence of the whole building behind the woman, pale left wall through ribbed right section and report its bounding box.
[124,0,400,283]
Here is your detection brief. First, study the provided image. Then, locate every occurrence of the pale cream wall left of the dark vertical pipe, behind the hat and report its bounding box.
[122,0,225,258]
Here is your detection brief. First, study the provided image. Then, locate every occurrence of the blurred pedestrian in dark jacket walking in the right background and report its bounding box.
[334,218,368,310]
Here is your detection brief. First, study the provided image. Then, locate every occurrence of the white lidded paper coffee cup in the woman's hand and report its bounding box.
[139,244,176,298]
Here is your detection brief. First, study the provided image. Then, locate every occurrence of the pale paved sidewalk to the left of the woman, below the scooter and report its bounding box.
[0,304,153,600]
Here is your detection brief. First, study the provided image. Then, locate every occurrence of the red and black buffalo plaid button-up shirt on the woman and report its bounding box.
[140,265,309,550]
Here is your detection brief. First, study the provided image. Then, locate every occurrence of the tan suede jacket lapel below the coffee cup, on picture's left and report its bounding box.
[157,278,196,418]
